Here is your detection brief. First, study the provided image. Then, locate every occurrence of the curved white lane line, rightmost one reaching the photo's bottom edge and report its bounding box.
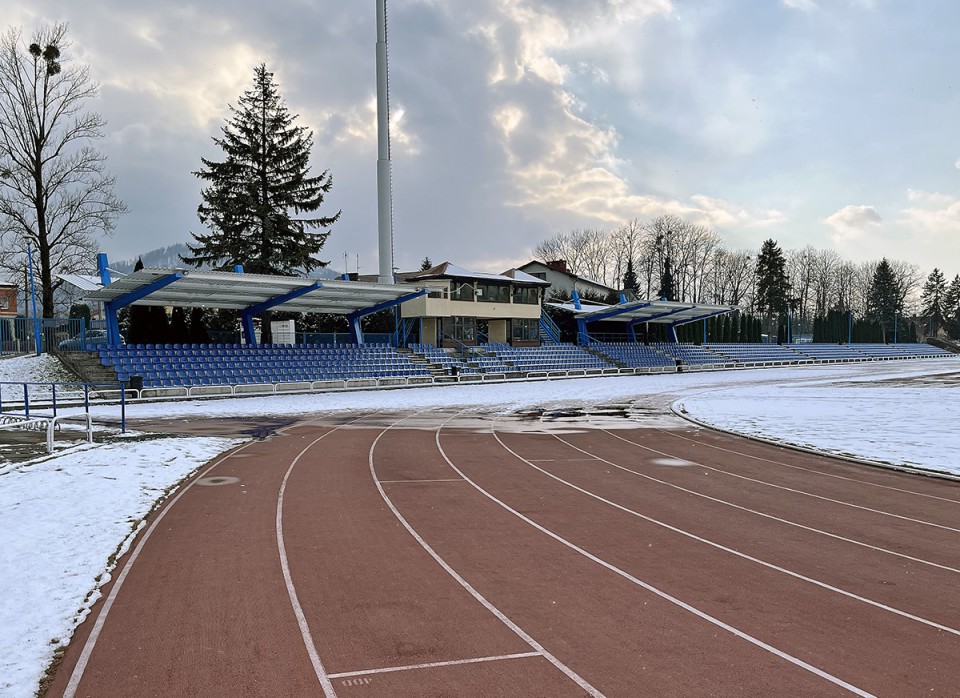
[436,430,873,698]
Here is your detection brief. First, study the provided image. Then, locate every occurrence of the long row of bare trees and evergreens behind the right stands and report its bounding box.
[534,215,960,341]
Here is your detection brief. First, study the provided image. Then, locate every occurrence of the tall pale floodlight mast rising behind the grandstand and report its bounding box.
[377,0,393,284]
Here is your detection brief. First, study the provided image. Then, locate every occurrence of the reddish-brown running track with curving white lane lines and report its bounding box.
[47,412,960,698]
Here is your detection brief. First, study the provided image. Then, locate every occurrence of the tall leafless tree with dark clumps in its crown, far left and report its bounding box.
[0,24,126,317]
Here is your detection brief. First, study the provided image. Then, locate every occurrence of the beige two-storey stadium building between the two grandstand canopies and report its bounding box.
[386,262,548,346]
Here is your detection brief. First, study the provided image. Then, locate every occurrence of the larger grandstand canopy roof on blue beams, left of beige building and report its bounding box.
[86,269,438,315]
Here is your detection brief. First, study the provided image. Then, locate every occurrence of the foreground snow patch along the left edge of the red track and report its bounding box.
[0,438,238,698]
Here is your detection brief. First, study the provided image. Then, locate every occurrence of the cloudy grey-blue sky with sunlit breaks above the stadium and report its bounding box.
[7,0,960,276]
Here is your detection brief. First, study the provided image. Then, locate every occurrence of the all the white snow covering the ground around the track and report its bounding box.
[0,357,960,698]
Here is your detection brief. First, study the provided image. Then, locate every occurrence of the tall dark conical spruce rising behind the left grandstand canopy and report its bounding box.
[182,64,340,342]
